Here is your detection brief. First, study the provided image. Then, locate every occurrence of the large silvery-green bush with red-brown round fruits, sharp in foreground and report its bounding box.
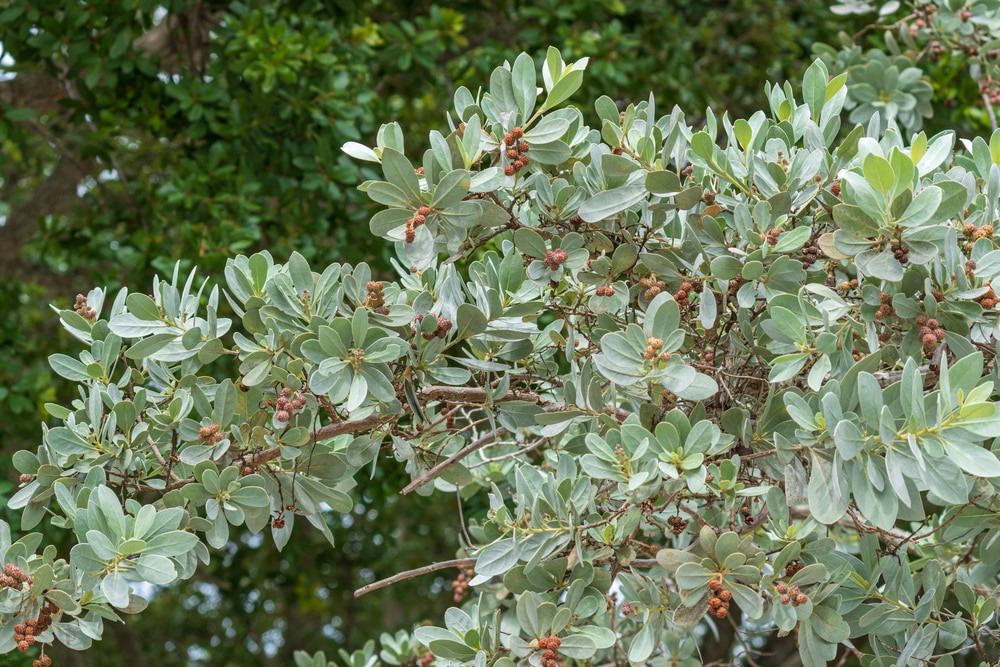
[0,49,1000,667]
